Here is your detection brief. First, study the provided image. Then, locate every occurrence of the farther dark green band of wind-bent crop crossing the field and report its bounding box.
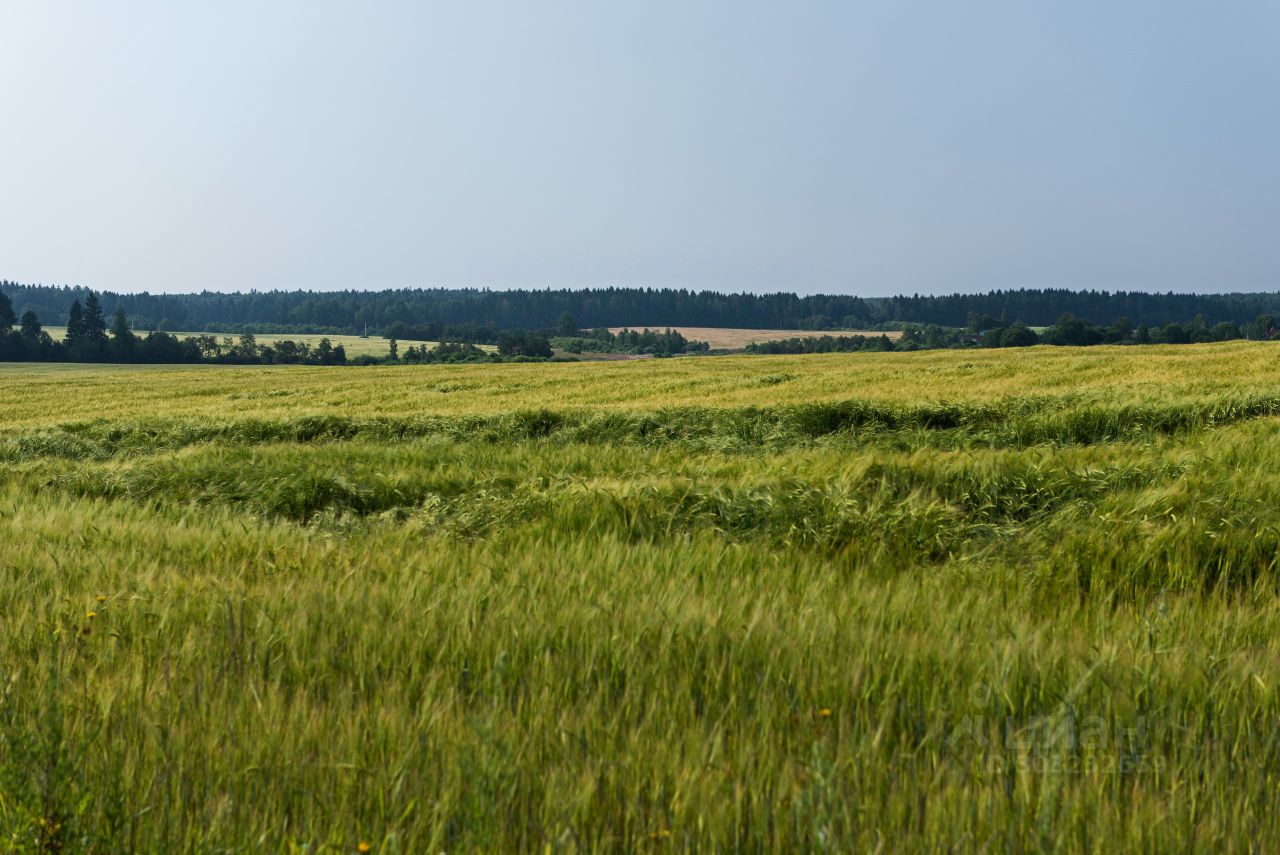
[0,394,1280,462]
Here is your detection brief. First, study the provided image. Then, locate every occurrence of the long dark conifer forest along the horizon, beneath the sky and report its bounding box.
[0,280,1280,334]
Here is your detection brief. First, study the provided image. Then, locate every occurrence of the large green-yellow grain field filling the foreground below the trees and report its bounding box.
[0,343,1280,852]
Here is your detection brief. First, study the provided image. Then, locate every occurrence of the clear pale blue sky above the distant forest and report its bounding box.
[0,0,1280,296]
